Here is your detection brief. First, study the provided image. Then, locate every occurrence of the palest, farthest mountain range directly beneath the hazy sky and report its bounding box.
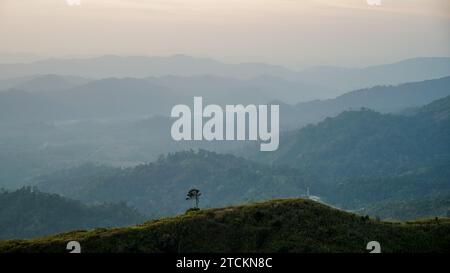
[0,55,450,94]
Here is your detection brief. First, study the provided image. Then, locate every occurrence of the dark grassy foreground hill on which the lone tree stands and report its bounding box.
[0,199,450,253]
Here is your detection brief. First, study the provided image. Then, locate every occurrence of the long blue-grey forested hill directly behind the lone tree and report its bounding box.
[36,150,312,217]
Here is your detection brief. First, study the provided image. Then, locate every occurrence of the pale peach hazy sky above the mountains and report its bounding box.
[0,0,450,66]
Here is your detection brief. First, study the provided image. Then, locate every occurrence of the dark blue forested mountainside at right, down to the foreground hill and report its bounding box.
[244,96,450,209]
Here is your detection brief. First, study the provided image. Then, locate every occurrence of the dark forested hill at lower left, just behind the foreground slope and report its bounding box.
[0,188,144,239]
